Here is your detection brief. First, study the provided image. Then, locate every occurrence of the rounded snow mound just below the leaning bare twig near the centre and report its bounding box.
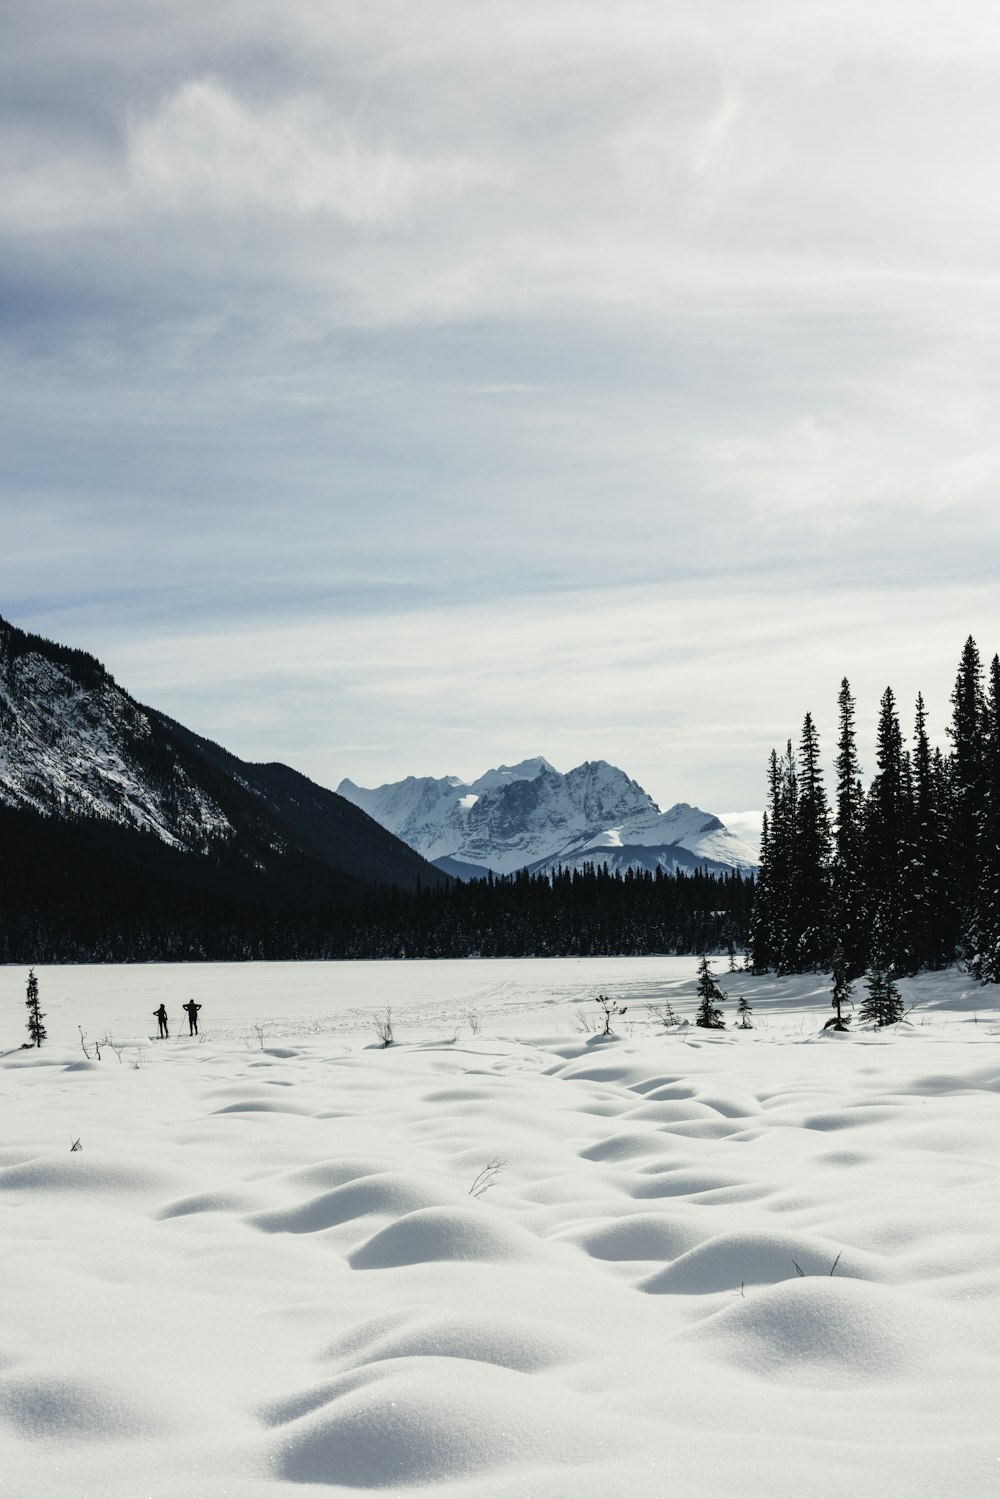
[348,1207,541,1270]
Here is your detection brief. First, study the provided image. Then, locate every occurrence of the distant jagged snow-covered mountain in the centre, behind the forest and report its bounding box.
[337,755,757,878]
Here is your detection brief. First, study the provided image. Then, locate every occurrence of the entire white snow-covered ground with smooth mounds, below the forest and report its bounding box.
[0,958,1000,1499]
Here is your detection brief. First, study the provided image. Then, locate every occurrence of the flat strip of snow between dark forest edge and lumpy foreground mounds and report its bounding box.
[0,956,997,1049]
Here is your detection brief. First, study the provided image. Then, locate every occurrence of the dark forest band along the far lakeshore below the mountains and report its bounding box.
[0,806,754,964]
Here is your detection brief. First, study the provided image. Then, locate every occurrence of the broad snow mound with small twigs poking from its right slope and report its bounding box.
[642,1229,888,1295]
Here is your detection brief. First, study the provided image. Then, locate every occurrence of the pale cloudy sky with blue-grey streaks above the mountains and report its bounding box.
[0,0,1000,812]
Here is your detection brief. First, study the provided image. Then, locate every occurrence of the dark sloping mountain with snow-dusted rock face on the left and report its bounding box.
[0,619,442,901]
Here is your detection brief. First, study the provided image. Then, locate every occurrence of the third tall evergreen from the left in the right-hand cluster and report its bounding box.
[783,714,834,973]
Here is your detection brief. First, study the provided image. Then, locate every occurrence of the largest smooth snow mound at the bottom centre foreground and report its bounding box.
[274,1358,621,1492]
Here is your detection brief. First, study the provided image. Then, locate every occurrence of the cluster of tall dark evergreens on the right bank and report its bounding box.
[750,636,1000,982]
